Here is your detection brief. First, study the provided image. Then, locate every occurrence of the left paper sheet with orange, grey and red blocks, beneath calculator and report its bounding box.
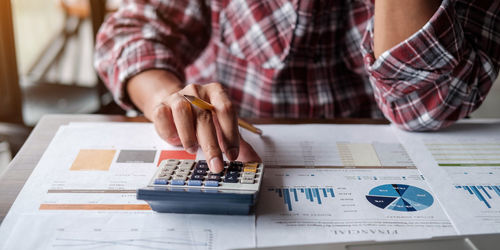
[0,123,255,249]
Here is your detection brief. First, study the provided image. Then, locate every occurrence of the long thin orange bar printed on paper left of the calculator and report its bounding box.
[39,204,151,210]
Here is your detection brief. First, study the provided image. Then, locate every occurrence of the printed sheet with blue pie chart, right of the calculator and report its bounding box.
[243,125,456,246]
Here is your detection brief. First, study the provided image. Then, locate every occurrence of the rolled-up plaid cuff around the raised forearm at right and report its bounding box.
[361,0,464,98]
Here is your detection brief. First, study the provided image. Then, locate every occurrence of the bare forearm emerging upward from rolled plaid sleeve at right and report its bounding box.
[373,0,441,58]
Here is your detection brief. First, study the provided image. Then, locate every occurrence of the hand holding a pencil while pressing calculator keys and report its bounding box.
[127,70,261,173]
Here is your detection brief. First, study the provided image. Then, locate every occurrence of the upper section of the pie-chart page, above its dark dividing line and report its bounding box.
[242,125,415,169]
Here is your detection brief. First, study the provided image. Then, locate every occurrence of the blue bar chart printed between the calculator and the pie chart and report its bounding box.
[267,187,335,211]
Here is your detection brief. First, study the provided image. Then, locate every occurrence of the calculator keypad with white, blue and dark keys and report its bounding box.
[151,159,262,188]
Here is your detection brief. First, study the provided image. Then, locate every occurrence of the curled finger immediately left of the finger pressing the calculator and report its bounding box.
[169,94,198,154]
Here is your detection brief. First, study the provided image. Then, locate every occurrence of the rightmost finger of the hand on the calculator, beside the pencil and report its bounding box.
[200,83,240,160]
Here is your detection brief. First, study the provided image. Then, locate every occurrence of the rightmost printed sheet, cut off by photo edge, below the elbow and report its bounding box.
[395,121,500,234]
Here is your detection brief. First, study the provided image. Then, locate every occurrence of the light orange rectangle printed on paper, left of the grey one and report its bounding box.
[70,149,116,171]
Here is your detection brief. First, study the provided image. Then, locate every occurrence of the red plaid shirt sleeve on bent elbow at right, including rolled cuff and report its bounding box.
[361,0,500,131]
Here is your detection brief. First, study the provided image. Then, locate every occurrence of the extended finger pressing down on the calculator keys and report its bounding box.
[196,109,224,173]
